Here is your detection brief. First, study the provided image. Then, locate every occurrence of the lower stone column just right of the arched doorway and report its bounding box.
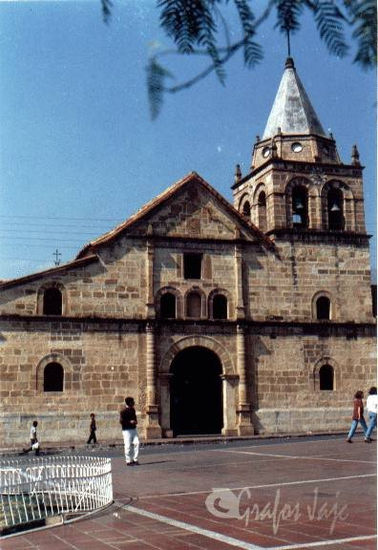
[236,325,253,435]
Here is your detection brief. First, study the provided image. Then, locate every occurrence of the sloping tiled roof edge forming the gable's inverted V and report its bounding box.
[77,172,274,258]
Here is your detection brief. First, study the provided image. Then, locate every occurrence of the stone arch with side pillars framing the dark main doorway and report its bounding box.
[158,336,239,436]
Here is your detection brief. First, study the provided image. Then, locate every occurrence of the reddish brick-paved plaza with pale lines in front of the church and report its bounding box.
[0,440,377,550]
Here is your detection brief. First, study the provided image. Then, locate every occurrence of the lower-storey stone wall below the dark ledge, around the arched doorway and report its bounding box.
[0,312,376,446]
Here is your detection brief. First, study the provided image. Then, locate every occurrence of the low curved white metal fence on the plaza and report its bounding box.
[0,456,113,530]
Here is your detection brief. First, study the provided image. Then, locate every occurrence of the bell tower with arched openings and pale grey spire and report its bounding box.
[232,57,366,238]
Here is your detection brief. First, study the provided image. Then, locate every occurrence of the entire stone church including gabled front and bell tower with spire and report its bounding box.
[0,58,376,446]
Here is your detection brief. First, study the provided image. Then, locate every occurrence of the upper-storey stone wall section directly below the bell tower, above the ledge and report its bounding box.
[244,238,374,323]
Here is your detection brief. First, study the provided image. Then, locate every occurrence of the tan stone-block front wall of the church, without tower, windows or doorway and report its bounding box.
[0,179,375,445]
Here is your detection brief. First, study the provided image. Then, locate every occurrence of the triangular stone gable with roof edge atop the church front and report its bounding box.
[77,172,274,258]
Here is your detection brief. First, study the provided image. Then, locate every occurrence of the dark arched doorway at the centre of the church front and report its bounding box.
[170,346,223,435]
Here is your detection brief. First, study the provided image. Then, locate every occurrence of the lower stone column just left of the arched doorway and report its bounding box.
[146,323,161,439]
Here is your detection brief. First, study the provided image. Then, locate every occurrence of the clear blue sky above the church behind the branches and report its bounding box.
[0,0,376,279]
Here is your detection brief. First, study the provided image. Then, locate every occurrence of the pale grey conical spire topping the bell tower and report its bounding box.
[262,57,327,139]
